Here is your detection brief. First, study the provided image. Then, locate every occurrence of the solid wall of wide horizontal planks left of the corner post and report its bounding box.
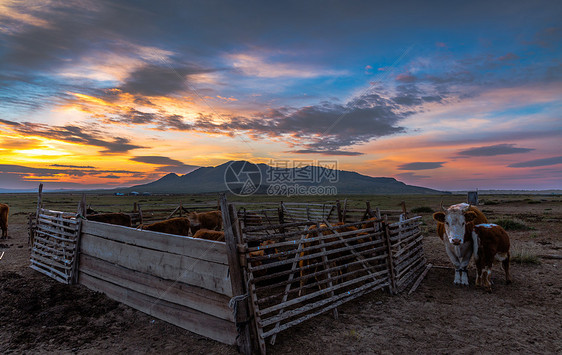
[78,221,237,344]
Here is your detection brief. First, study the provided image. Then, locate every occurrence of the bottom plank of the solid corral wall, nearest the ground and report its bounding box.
[80,273,236,345]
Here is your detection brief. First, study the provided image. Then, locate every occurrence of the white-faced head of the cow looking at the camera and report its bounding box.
[433,204,476,245]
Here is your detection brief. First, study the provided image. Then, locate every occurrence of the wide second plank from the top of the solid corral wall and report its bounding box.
[80,233,232,296]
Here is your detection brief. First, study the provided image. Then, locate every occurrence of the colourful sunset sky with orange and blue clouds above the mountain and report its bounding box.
[0,0,562,190]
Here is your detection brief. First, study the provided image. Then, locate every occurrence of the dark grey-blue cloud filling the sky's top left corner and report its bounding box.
[0,0,160,70]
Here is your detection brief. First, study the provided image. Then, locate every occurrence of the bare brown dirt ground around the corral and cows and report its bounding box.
[0,200,562,354]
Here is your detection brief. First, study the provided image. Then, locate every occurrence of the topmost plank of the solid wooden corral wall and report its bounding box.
[82,221,228,265]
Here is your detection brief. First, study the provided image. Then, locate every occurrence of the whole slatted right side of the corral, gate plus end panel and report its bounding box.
[228,199,426,354]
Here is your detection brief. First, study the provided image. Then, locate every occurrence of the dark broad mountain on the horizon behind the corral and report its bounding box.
[119,161,443,195]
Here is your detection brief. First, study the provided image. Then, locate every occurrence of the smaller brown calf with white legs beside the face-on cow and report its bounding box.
[472,223,511,292]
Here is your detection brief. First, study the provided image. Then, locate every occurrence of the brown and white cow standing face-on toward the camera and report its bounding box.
[433,203,488,285]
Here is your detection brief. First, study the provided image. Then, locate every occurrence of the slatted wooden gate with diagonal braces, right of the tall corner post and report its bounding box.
[232,209,390,353]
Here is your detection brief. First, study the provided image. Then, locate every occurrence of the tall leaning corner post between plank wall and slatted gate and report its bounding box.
[220,193,252,355]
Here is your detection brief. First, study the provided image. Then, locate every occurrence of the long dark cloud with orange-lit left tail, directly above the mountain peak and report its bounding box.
[144,93,406,155]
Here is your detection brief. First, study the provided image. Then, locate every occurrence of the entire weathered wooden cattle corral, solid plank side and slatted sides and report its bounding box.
[31,195,426,353]
